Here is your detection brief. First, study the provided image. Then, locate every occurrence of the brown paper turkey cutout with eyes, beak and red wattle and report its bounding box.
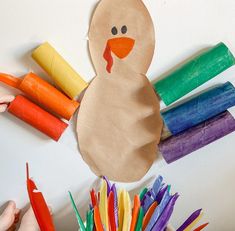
[77,0,162,182]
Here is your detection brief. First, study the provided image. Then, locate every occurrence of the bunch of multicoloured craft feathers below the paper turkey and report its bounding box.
[69,176,208,231]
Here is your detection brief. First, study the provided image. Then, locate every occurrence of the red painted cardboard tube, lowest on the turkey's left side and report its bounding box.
[8,95,68,141]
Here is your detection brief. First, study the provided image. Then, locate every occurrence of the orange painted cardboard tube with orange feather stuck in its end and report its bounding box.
[0,73,79,120]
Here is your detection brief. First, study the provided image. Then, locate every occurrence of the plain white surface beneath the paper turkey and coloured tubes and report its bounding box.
[0,0,235,231]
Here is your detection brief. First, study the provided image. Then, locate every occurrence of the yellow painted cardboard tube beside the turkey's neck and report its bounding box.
[32,42,87,99]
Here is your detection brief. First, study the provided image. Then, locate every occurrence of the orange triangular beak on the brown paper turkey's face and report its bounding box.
[108,37,135,59]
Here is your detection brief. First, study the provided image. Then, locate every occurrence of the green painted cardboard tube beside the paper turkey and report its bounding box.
[154,43,235,105]
